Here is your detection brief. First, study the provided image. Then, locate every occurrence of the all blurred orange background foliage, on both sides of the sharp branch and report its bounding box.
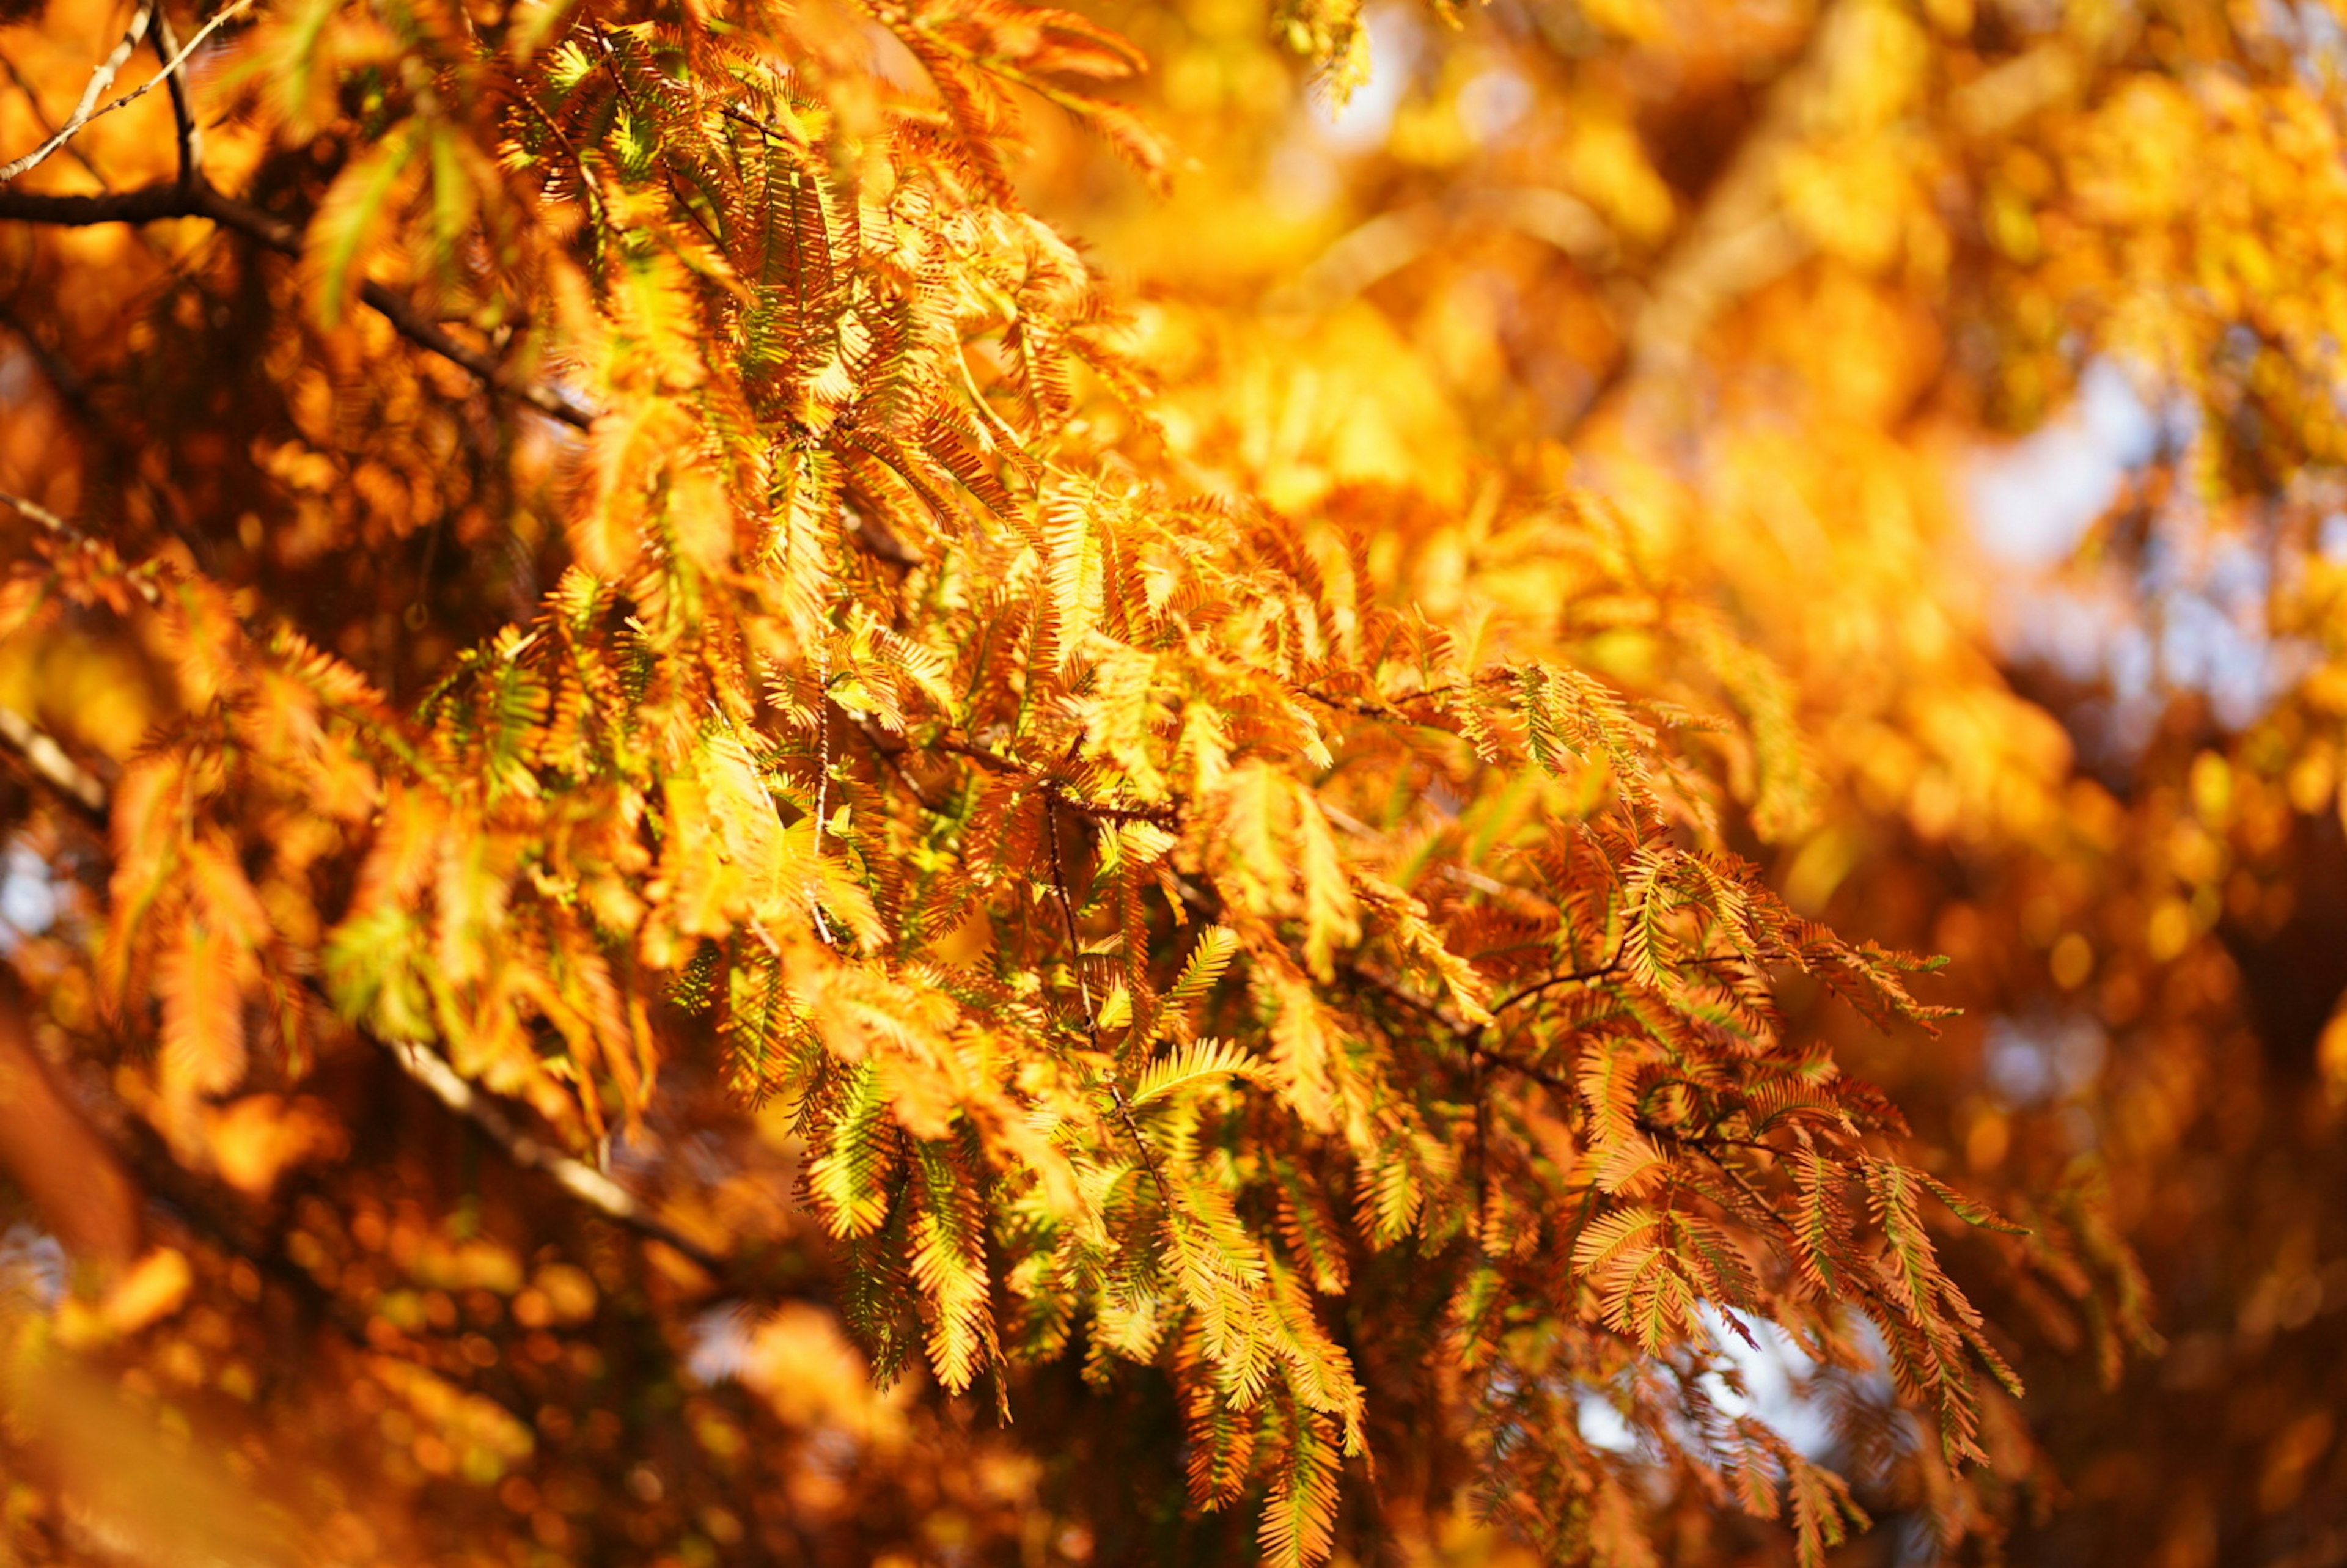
[0,0,2347,1568]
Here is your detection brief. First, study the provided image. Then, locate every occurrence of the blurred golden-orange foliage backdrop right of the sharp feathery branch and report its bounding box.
[1035,0,2347,1566]
